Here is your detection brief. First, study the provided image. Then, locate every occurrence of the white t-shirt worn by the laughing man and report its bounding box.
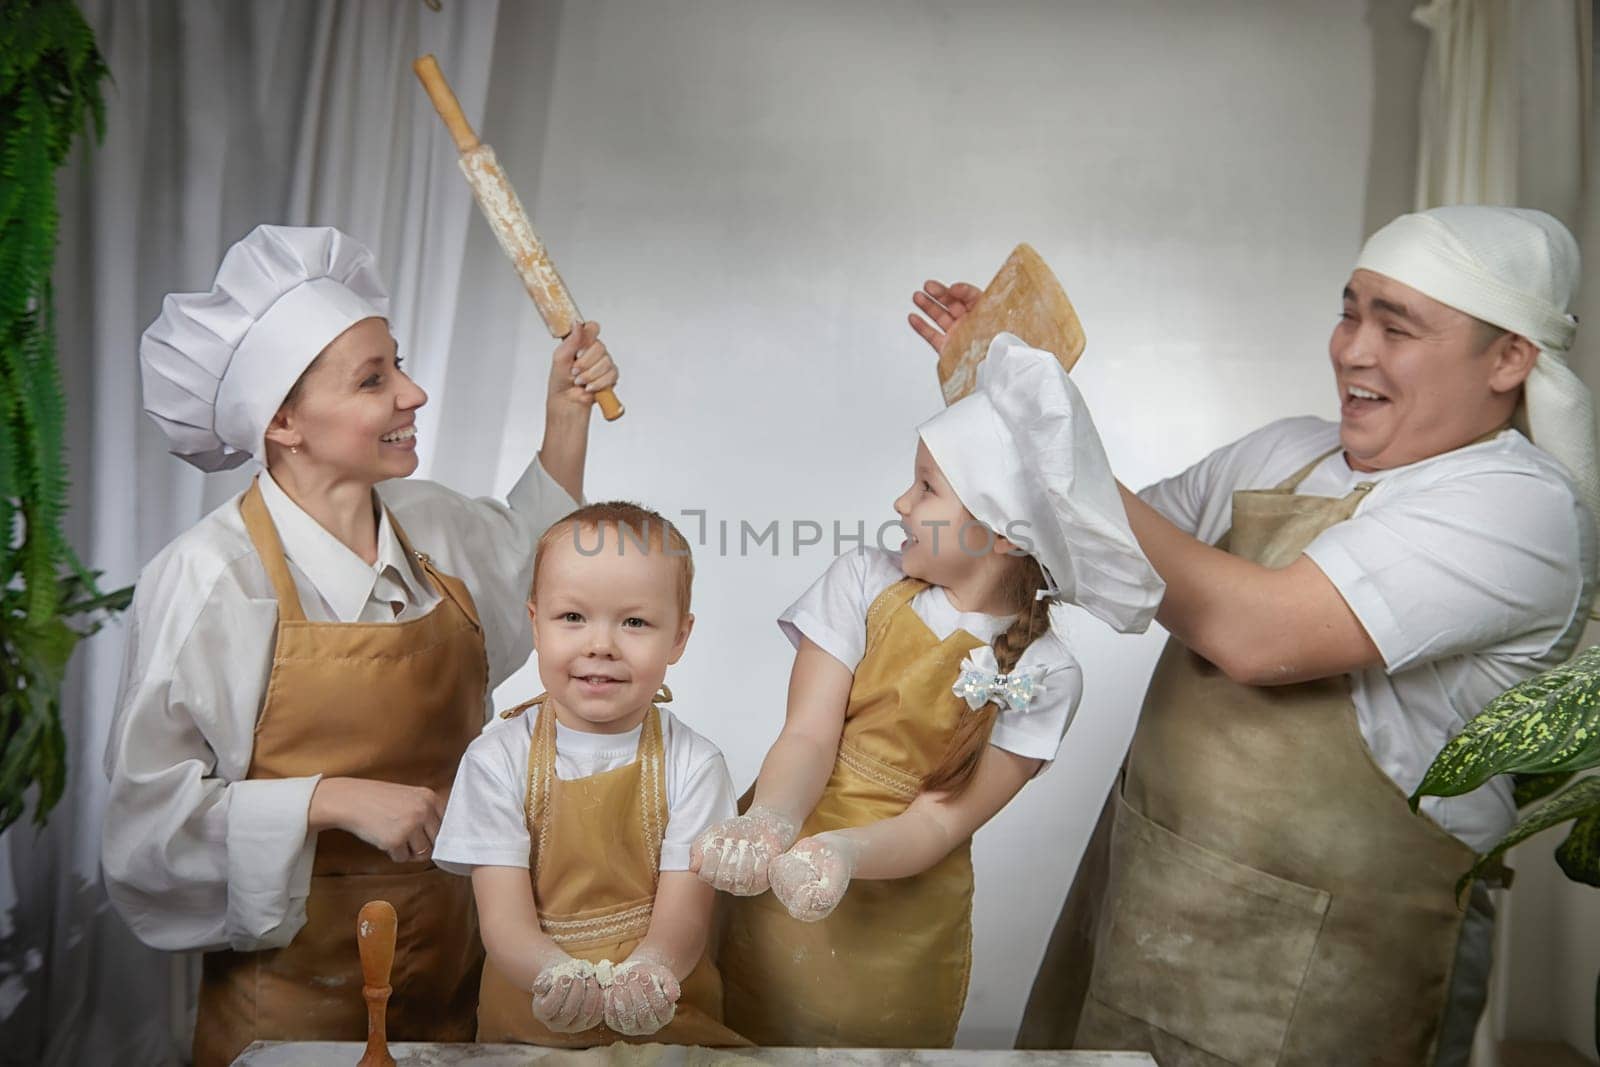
[1139,418,1595,851]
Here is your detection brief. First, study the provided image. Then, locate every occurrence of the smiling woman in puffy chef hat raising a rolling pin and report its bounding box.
[102,226,616,1065]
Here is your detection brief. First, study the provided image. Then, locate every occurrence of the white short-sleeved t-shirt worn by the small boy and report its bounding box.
[434,707,736,875]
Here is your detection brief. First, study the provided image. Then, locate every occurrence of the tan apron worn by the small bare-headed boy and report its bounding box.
[478,697,749,1048]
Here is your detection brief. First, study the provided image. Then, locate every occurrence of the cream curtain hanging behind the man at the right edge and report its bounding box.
[1414,0,1600,1067]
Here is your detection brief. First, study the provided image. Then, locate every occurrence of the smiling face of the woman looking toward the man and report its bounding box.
[269,318,427,483]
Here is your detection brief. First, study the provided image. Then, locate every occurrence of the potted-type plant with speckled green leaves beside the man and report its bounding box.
[1411,646,1600,1051]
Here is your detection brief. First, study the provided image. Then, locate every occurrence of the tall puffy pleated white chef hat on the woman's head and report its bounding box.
[139,226,389,470]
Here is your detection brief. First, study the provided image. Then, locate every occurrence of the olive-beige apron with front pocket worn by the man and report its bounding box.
[1019,453,1474,1067]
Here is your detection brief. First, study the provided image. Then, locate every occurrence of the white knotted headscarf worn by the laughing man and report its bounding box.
[1355,205,1600,517]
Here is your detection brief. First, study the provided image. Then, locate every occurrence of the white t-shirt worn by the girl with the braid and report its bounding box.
[778,547,1083,763]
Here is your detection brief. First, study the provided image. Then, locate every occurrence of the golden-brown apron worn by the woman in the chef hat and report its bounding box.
[194,485,488,1067]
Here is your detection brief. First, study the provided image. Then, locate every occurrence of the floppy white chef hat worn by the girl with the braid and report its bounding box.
[917,333,1166,633]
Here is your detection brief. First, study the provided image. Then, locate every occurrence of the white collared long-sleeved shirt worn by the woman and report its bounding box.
[101,461,576,950]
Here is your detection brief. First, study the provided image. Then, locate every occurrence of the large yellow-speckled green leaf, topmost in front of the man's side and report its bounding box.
[1411,646,1600,811]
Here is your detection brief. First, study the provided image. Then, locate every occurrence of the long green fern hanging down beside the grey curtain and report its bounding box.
[0,0,131,830]
